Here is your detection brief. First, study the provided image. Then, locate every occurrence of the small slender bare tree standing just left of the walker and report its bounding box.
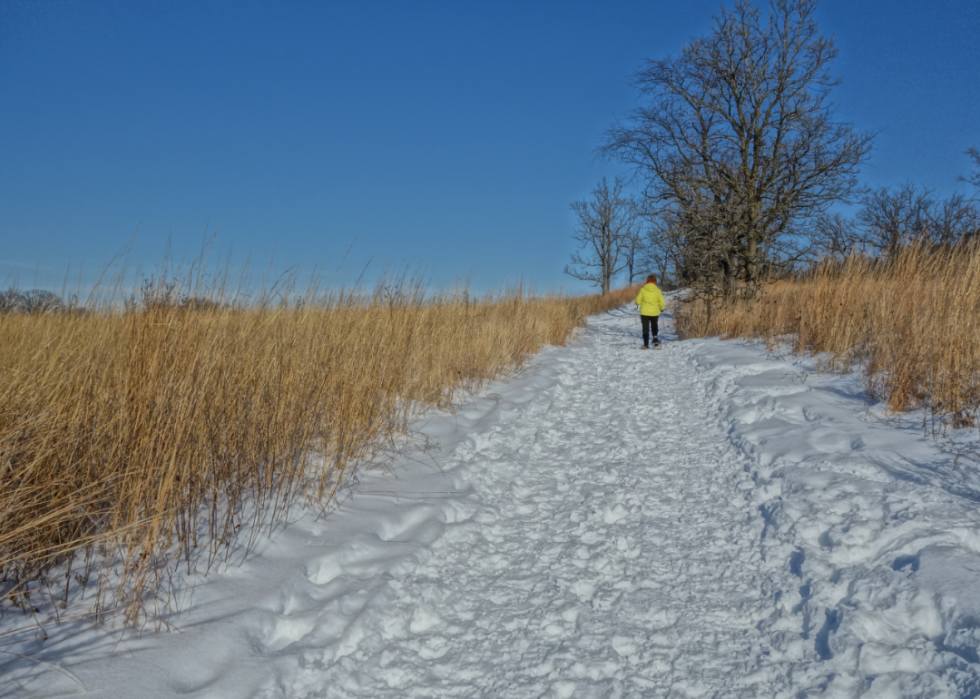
[565,177,637,294]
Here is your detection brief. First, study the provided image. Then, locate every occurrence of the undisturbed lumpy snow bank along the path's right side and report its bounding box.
[692,340,980,697]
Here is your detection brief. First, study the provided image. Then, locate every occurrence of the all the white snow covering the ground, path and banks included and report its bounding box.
[0,302,980,699]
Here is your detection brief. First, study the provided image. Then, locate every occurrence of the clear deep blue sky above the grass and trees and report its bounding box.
[0,0,980,292]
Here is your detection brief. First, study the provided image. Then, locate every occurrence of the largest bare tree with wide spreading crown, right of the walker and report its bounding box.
[600,0,871,285]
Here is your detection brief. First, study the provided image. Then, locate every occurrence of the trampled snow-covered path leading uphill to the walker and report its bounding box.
[289,315,789,697]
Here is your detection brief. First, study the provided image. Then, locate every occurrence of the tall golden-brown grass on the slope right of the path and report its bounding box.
[678,245,980,424]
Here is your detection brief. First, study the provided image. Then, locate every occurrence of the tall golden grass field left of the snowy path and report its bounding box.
[0,284,634,622]
